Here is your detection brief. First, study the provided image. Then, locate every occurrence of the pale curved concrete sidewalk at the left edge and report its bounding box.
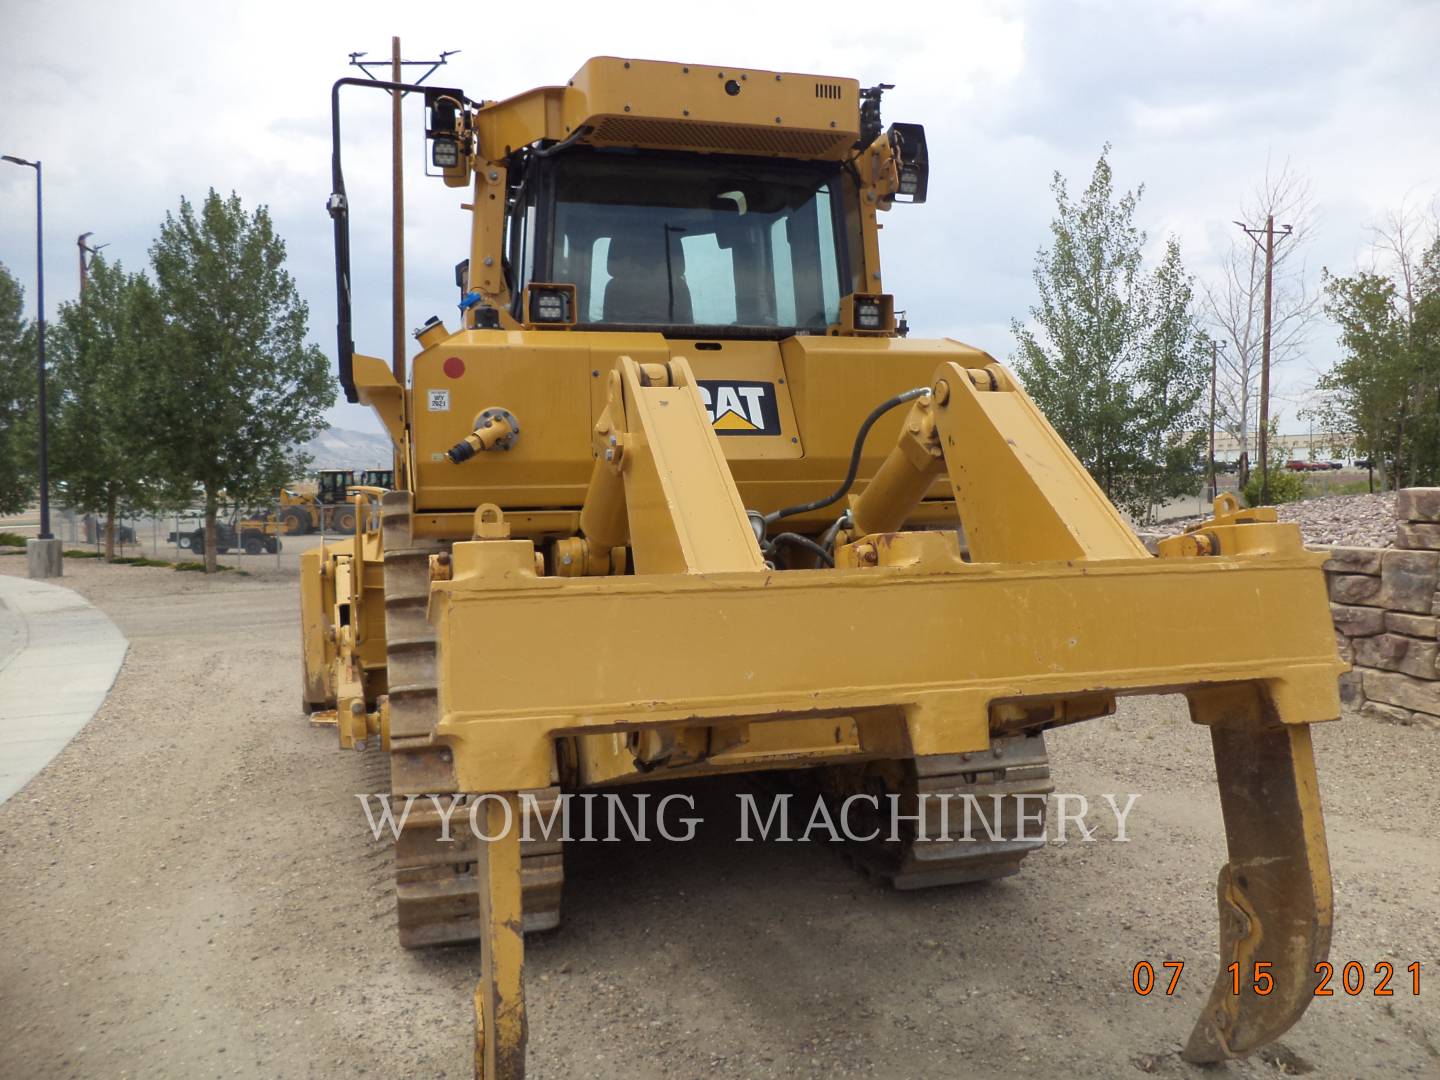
[0,575,130,802]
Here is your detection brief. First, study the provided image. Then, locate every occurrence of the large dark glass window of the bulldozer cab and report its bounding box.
[529,154,844,336]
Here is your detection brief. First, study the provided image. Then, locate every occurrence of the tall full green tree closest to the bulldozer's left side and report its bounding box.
[150,189,334,572]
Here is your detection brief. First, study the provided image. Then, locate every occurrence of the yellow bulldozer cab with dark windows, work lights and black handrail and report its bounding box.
[328,56,929,408]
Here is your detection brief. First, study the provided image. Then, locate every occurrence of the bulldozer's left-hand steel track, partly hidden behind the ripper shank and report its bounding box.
[383,492,564,949]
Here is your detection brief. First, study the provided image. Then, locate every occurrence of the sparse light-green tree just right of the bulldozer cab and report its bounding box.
[1012,144,1210,518]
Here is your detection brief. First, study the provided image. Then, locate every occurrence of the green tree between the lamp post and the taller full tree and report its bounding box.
[50,256,166,559]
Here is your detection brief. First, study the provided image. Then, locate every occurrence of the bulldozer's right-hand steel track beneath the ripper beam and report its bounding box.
[825,734,1054,890]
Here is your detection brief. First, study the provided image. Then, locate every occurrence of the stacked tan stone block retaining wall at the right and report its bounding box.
[1325,488,1440,732]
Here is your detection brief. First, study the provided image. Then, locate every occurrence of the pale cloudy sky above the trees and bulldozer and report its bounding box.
[0,0,1440,432]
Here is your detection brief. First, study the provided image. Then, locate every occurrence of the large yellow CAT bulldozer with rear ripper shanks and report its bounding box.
[301,58,1345,1080]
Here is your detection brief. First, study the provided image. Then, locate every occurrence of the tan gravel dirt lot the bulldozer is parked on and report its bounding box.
[0,557,1440,1080]
